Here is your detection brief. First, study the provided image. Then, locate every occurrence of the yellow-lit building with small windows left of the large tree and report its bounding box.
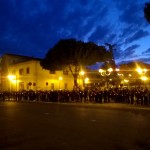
[0,54,74,91]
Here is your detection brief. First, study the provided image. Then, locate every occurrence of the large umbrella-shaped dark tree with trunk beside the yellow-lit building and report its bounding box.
[40,39,110,87]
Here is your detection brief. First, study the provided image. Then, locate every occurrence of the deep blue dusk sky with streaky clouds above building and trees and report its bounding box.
[0,0,150,63]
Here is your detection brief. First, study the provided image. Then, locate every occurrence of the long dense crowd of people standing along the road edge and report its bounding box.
[0,87,150,105]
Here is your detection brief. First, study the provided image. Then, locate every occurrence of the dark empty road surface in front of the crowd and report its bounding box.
[0,102,150,150]
